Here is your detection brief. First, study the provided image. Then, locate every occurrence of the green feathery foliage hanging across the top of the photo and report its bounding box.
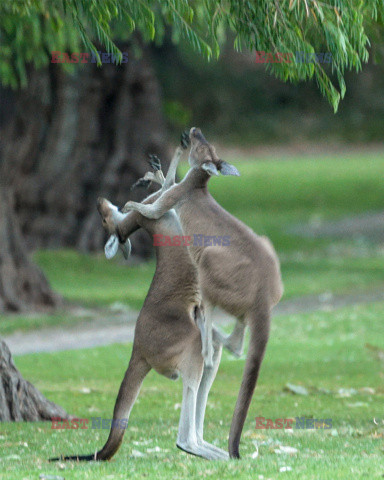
[0,0,384,111]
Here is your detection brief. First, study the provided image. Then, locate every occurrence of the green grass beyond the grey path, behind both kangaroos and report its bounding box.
[0,154,384,334]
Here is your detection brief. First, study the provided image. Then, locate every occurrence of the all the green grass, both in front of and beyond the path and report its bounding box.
[0,151,384,480]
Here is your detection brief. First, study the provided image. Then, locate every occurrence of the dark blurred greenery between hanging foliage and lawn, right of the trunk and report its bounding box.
[153,40,384,146]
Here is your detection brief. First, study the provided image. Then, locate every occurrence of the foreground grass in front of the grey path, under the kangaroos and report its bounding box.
[0,303,384,480]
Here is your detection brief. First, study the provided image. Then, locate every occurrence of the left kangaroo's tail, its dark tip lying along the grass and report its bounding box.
[50,353,151,462]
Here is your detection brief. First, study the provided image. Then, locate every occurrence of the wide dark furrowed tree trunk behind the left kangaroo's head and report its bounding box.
[2,41,167,256]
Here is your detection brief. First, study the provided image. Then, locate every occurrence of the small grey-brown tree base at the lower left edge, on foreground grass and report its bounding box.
[0,338,69,422]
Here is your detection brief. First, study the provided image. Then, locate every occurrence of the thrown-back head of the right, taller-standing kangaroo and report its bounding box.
[189,127,240,176]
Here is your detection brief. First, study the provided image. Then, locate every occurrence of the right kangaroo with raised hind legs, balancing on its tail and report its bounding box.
[116,128,283,458]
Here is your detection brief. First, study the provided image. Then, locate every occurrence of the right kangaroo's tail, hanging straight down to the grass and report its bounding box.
[228,304,270,458]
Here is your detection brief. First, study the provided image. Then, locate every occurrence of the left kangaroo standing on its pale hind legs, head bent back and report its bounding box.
[49,199,229,461]
